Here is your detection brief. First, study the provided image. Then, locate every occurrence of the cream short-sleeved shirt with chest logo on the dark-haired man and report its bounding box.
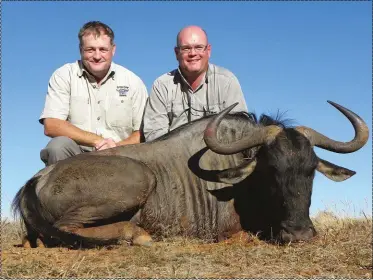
[39,61,147,142]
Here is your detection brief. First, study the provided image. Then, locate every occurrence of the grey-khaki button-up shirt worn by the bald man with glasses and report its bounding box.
[144,64,247,141]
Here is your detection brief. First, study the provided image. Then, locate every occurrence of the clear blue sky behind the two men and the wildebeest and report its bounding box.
[1,1,372,217]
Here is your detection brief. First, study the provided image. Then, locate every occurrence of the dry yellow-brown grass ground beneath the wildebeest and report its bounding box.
[1,212,372,278]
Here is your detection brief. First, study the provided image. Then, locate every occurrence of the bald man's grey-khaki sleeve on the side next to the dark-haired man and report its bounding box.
[144,80,169,142]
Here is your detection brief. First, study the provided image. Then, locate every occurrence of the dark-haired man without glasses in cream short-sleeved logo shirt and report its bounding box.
[39,21,148,166]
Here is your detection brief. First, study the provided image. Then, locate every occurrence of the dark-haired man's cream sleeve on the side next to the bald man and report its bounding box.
[132,79,148,131]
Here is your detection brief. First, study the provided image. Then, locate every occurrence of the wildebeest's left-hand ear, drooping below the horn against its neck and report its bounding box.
[217,159,256,185]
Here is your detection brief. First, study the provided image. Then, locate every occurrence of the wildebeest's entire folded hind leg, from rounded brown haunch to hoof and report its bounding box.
[27,154,156,246]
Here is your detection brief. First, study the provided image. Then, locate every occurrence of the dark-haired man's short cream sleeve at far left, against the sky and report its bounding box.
[39,68,70,124]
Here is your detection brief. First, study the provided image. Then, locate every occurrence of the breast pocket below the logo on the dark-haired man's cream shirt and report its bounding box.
[106,96,132,127]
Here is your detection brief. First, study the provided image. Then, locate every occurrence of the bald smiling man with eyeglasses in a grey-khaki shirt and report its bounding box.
[143,26,247,141]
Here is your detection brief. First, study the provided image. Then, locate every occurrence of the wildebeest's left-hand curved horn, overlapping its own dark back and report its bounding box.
[204,103,281,155]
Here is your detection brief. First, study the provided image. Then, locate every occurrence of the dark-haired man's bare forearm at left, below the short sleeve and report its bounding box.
[44,118,103,147]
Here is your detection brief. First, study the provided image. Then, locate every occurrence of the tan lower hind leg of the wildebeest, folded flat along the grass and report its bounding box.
[60,221,153,246]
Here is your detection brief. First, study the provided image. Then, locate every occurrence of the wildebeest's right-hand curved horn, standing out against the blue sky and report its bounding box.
[295,100,369,154]
